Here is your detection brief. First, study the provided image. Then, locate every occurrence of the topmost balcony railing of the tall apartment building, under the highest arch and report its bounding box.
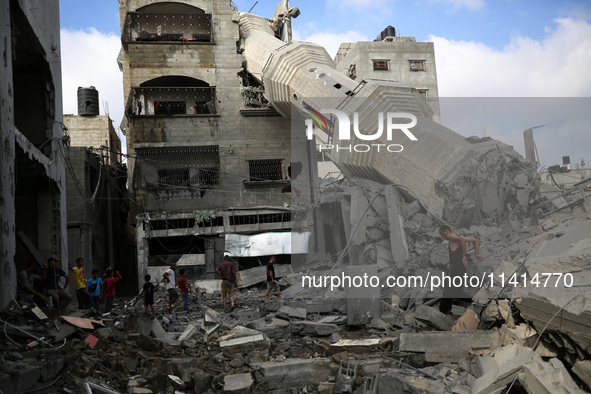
[121,12,213,49]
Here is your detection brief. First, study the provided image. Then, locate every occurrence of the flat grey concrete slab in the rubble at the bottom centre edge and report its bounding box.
[251,358,337,390]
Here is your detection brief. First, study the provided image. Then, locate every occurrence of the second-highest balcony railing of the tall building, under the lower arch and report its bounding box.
[125,87,217,117]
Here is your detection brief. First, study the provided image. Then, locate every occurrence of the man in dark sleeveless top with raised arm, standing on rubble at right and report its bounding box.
[439,225,484,314]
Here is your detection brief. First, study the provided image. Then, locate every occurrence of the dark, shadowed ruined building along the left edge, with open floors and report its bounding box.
[0,0,67,308]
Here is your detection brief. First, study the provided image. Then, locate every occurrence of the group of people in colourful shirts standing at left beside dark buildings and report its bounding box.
[17,257,122,314]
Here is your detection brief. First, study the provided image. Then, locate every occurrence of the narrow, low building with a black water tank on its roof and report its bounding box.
[64,86,136,284]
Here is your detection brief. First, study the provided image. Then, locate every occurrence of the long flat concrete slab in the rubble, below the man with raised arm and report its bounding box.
[399,330,501,363]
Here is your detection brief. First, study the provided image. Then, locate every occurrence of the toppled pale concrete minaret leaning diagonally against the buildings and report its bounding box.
[239,10,536,226]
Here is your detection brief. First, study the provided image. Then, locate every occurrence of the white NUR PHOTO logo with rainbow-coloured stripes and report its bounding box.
[304,105,417,152]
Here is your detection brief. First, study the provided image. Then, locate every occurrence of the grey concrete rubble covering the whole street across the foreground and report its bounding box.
[0,174,591,393]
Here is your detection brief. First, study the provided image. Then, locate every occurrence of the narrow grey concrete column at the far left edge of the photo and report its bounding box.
[0,1,16,309]
